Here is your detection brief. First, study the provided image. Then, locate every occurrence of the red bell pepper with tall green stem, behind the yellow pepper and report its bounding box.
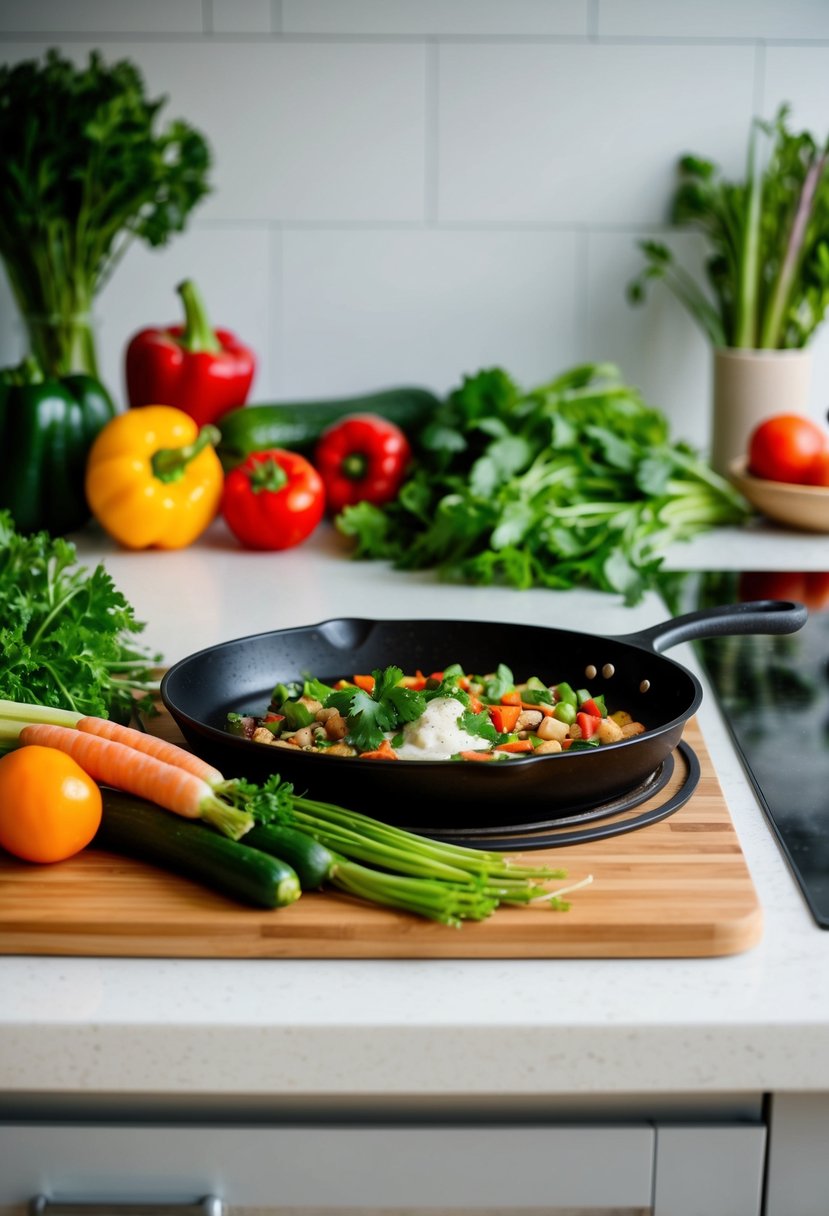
[126,280,256,427]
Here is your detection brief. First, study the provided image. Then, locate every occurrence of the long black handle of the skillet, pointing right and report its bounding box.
[616,599,808,654]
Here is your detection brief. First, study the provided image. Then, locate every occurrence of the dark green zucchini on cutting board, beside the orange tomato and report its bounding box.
[92,788,301,908]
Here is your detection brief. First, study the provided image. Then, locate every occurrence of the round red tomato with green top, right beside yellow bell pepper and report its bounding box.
[221,447,326,550]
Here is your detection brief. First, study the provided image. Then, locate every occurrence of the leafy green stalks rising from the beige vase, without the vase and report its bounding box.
[628,106,829,349]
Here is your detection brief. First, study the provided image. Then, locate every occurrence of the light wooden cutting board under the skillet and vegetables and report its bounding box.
[0,717,762,958]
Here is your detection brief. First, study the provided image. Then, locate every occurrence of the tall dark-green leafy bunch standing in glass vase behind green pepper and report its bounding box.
[0,49,210,376]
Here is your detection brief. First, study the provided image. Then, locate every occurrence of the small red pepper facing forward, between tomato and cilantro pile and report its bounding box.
[314,413,412,514]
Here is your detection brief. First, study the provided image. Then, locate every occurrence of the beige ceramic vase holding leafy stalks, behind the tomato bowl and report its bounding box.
[711,348,812,477]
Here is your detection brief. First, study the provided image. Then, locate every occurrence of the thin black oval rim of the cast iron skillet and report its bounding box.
[160,617,703,781]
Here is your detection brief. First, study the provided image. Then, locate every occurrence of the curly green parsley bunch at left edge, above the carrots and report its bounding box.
[0,511,159,721]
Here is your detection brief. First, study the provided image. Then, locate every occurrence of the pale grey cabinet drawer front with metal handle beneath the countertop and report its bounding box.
[0,1121,765,1216]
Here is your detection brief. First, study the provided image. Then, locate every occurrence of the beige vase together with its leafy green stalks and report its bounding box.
[628,106,829,474]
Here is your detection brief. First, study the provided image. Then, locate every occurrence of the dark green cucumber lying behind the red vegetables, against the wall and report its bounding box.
[216,388,440,469]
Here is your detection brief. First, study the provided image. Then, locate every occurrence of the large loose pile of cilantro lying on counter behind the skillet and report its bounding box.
[337,365,748,603]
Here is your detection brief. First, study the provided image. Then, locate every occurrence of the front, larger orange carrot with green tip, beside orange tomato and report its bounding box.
[19,722,253,840]
